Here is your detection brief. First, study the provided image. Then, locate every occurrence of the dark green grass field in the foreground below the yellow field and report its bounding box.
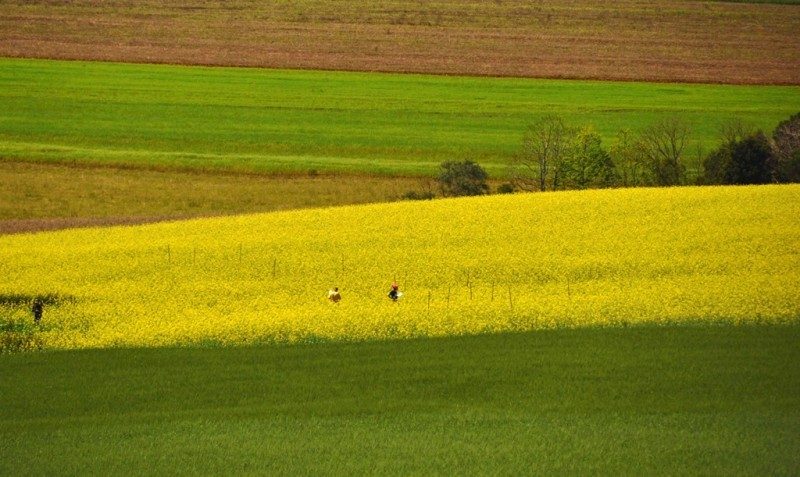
[0,326,800,475]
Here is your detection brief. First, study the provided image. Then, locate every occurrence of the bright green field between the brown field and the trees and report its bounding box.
[0,59,800,177]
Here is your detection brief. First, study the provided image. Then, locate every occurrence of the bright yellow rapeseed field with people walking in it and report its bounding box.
[0,186,800,348]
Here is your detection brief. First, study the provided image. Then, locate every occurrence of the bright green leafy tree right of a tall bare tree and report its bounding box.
[565,127,615,189]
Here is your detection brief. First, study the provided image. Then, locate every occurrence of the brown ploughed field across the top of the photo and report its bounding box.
[0,0,800,84]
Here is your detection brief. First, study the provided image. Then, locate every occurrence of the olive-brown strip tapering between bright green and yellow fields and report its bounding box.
[0,161,434,235]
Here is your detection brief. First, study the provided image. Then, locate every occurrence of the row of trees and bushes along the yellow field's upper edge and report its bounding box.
[428,113,800,198]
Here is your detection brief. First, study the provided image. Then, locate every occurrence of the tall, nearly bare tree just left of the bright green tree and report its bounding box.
[513,115,577,191]
